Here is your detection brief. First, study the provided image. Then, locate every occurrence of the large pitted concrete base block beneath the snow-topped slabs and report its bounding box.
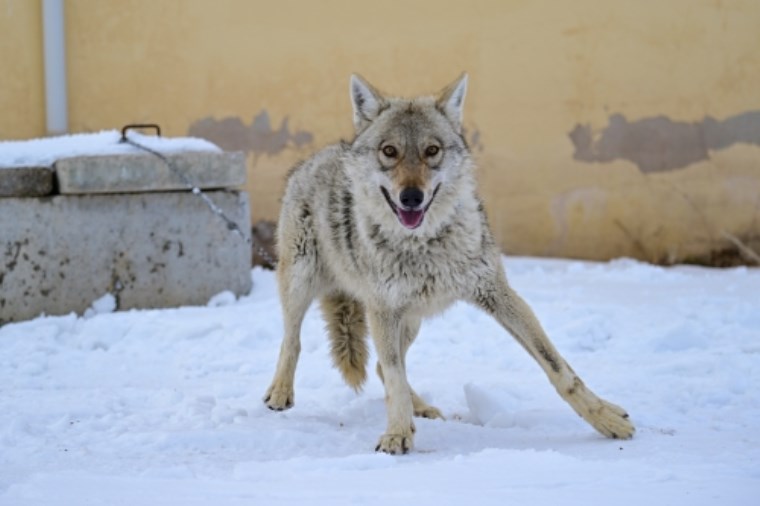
[0,191,251,324]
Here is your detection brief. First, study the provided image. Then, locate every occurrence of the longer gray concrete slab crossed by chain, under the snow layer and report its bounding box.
[54,151,246,195]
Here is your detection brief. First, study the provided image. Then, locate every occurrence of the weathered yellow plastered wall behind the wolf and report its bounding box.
[0,0,760,261]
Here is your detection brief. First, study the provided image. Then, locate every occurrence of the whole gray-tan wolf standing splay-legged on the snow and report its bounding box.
[264,74,635,454]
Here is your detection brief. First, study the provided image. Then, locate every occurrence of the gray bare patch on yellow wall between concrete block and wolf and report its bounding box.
[188,110,314,158]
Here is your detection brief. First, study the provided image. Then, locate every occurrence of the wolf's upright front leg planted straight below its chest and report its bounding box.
[368,310,414,455]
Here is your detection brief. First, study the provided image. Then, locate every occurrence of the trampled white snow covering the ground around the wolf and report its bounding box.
[0,258,760,506]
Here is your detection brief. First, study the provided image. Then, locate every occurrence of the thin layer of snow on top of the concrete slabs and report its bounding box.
[0,130,221,169]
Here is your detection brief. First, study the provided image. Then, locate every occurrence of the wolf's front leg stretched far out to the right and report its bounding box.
[471,265,636,439]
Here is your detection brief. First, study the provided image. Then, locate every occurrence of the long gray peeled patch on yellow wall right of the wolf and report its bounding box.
[568,111,760,173]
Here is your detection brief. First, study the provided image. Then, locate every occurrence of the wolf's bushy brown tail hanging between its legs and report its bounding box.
[320,294,369,391]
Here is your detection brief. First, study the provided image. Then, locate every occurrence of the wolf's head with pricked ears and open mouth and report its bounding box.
[346,74,472,230]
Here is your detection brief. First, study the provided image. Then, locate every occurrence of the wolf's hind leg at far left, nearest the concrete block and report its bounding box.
[264,258,316,411]
